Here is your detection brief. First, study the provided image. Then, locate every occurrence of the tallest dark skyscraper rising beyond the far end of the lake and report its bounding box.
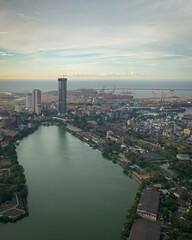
[58,78,67,114]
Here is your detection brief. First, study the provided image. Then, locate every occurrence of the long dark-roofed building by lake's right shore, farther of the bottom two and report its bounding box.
[137,189,160,221]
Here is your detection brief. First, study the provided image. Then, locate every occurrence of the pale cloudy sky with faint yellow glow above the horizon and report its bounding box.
[0,0,192,81]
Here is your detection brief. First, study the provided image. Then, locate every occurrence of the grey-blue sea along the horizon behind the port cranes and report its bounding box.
[0,79,192,98]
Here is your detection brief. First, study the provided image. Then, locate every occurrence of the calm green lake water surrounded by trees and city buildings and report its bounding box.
[0,126,139,240]
